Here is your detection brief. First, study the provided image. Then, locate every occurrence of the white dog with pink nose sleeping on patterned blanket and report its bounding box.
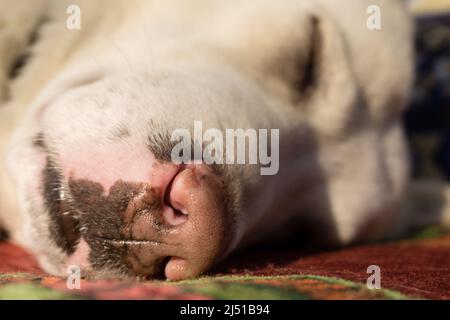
[0,0,450,279]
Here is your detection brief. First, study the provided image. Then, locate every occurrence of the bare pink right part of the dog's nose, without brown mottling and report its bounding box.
[163,165,231,280]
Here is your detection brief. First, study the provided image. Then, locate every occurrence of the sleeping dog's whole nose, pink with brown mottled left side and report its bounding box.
[122,165,230,280]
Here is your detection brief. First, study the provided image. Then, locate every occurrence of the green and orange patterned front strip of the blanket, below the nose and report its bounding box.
[0,273,409,300]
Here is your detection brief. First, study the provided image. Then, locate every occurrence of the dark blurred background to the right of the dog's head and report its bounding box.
[404,0,450,181]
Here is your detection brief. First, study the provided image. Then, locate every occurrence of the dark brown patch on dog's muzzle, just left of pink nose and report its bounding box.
[69,179,172,277]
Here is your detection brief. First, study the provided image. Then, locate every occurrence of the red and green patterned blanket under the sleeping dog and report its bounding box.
[0,228,450,300]
